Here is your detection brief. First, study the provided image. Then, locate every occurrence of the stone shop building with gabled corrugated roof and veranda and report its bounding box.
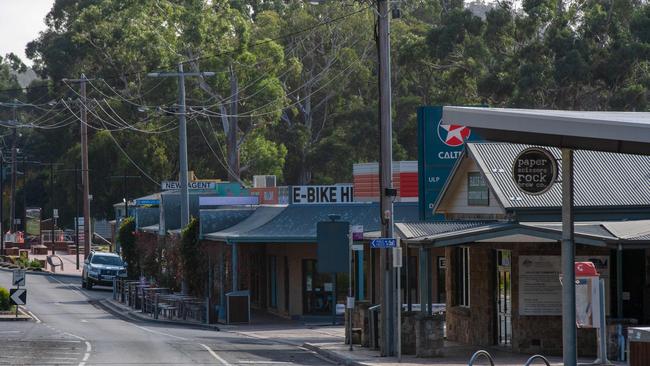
[406,139,650,356]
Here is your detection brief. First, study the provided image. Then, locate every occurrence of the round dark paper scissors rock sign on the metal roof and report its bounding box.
[512,147,557,195]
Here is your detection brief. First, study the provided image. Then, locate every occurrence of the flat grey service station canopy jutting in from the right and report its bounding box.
[442,107,650,155]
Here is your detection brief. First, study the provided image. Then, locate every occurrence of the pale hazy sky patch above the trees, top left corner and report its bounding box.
[0,0,54,65]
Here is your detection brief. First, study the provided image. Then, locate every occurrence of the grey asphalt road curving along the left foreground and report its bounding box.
[0,271,330,366]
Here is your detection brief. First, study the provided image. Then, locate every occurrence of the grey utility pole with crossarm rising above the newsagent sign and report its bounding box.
[147,62,215,228]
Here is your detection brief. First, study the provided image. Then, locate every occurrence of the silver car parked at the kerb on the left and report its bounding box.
[81,252,126,290]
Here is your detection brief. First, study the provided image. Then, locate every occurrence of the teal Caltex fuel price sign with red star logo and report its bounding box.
[417,106,481,220]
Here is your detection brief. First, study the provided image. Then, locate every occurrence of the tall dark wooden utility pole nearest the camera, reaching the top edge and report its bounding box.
[377,0,392,356]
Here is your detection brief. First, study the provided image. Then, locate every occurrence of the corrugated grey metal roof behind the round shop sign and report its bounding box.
[467,143,650,208]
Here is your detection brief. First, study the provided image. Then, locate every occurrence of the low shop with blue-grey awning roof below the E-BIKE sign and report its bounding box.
[201,202,417,320]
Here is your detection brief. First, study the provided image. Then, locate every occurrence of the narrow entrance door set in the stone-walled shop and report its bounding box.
[496,250,512,346]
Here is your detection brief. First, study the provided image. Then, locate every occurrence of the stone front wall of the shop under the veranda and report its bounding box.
[445,243,611,356]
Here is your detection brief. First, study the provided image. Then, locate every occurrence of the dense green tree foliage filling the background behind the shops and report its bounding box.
[0,0,650,226]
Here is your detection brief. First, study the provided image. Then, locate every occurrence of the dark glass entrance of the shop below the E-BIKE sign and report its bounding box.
[302,259,334,315]
